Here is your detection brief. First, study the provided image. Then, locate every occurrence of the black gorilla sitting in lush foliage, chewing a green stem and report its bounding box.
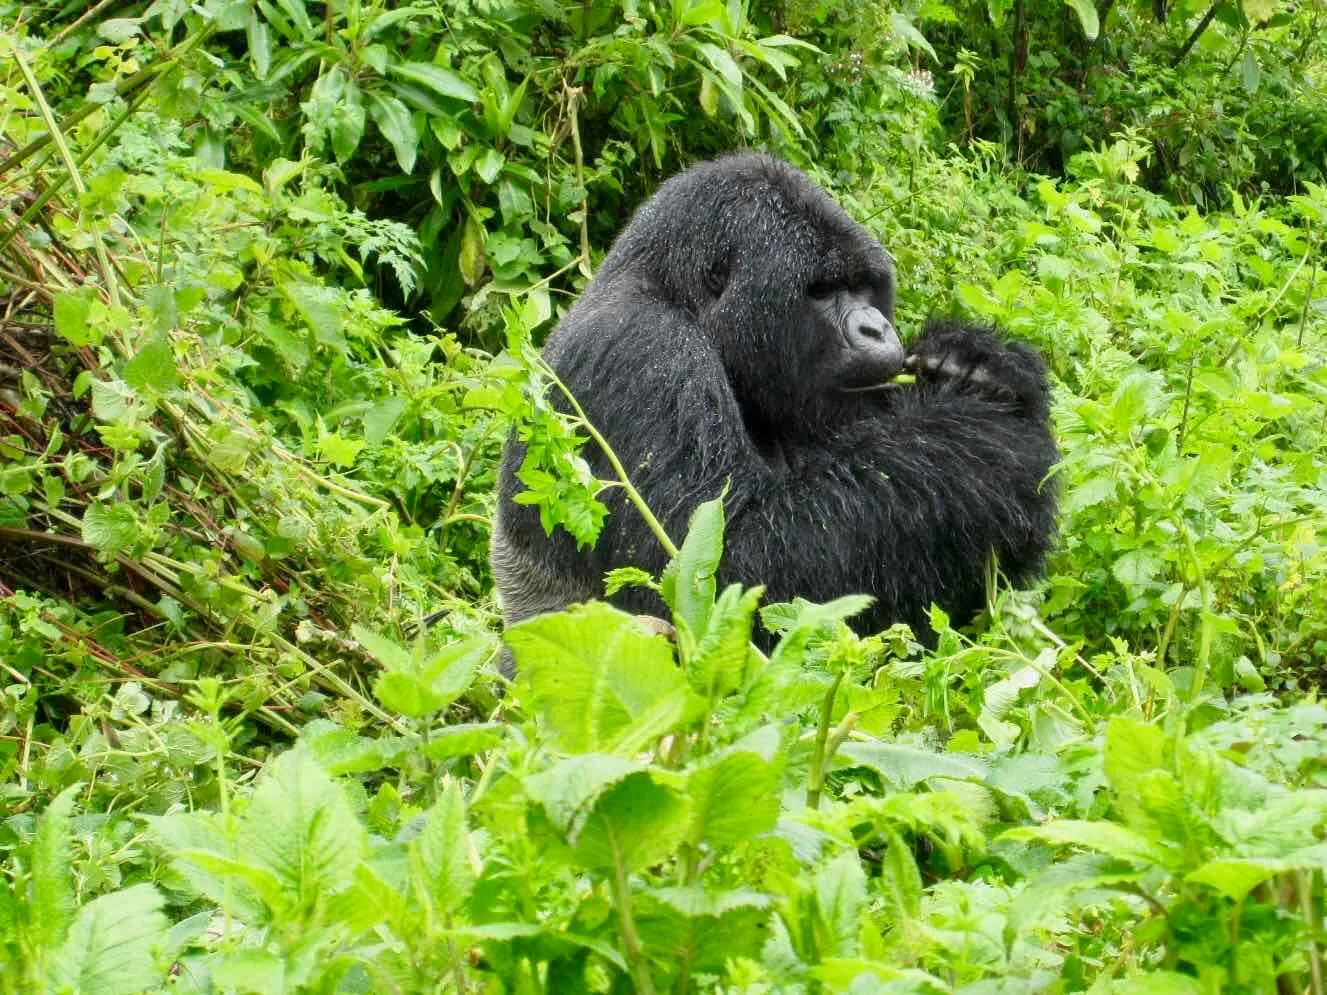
[492,147,1056,647]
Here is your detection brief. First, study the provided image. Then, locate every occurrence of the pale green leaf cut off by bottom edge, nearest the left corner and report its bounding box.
[50,885,170,995]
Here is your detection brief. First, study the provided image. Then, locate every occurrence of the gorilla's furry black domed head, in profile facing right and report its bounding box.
[596,155,904,426]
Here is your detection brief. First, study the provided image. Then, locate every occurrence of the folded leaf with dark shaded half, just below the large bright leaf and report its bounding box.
[525,754,687,870]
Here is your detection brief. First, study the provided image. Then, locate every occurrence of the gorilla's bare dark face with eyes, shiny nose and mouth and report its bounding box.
[808,284,904,391]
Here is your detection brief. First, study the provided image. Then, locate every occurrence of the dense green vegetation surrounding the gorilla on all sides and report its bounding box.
[0,0,1327,995]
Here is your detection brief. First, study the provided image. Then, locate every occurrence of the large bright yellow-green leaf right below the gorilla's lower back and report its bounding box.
[503,602,690,754]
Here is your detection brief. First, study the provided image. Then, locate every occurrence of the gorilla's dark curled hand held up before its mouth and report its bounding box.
[905,321,1050,418]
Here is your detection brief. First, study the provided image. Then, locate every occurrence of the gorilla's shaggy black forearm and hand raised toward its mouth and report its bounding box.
[725,339,1058,634]
